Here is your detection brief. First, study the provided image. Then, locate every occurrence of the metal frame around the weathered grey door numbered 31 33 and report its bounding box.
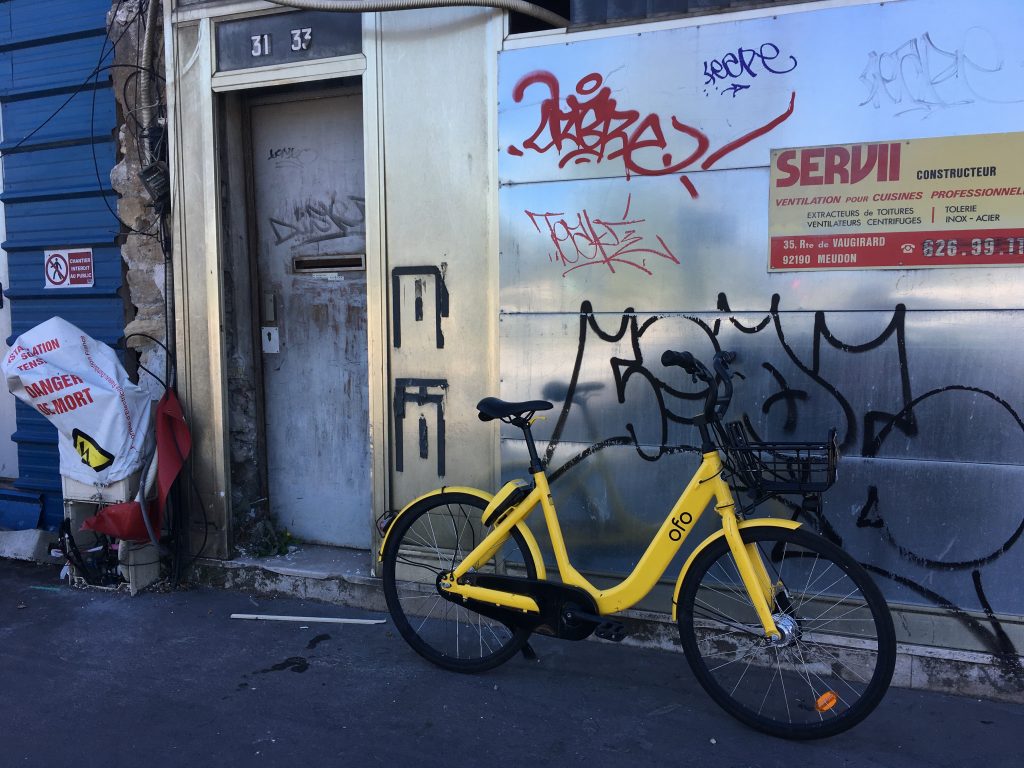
[164,9,390,558]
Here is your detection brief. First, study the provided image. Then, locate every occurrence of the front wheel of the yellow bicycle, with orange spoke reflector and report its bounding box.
[677,527,896,738]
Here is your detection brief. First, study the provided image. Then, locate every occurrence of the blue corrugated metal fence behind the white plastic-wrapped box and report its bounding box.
[0,0,125,529]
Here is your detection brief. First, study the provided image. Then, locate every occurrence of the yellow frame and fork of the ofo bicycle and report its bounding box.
[444,451,780,637]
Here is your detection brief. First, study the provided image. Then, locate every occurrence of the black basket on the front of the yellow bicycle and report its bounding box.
[724,422,839,496]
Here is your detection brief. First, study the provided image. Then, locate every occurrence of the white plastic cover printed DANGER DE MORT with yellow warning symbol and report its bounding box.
[3,317,153,485]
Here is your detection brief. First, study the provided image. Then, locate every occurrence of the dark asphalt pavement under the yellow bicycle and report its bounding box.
[0,560,1024,768]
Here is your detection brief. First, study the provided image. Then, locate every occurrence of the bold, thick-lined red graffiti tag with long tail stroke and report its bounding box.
[508,70,797,198]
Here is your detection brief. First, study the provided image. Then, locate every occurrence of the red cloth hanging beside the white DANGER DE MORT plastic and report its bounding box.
[82,389,191,542]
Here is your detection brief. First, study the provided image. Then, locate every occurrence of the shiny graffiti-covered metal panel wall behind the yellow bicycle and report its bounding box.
[495,0,1024,671]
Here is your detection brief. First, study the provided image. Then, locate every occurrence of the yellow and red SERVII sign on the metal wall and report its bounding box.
[768,133,1024,270]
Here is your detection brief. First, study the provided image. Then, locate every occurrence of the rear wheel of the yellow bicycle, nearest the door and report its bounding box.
[382,493,537,673]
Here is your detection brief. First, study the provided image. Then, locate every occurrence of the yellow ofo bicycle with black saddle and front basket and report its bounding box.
[380,351,896,738]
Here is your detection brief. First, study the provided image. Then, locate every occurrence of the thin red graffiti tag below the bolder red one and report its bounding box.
[524,196,679,278]
